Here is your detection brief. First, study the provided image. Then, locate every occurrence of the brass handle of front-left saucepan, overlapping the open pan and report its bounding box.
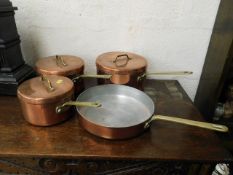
[56,101,101,114]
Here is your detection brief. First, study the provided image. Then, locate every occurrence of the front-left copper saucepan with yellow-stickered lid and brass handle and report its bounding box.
[17,75,99,126]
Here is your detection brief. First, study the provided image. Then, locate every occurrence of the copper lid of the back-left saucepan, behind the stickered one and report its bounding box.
[36,55,84,76]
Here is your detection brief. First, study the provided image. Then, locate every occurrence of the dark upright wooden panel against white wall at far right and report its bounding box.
[194,0,233,120]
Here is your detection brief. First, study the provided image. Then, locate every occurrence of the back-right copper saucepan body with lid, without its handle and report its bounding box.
[96,51,147,89]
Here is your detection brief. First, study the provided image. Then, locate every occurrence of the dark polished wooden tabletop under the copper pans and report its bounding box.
[0,80,233,162]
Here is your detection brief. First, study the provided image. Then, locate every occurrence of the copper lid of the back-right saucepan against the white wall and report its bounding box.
[96,52,147,74]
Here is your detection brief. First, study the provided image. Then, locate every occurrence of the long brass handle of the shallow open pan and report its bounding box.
[145,115,229,132]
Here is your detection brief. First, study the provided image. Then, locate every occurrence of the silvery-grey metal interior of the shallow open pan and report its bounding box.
[77,84,155,128]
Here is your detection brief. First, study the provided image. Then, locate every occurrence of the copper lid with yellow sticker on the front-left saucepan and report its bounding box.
[17,75,74,104]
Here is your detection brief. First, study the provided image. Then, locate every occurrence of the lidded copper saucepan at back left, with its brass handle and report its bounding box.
[35,55,110,95]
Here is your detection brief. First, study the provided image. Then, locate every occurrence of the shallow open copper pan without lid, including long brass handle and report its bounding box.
[72,84,228,139]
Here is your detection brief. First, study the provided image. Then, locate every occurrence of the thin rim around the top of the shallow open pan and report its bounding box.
[76,84,155,129]
